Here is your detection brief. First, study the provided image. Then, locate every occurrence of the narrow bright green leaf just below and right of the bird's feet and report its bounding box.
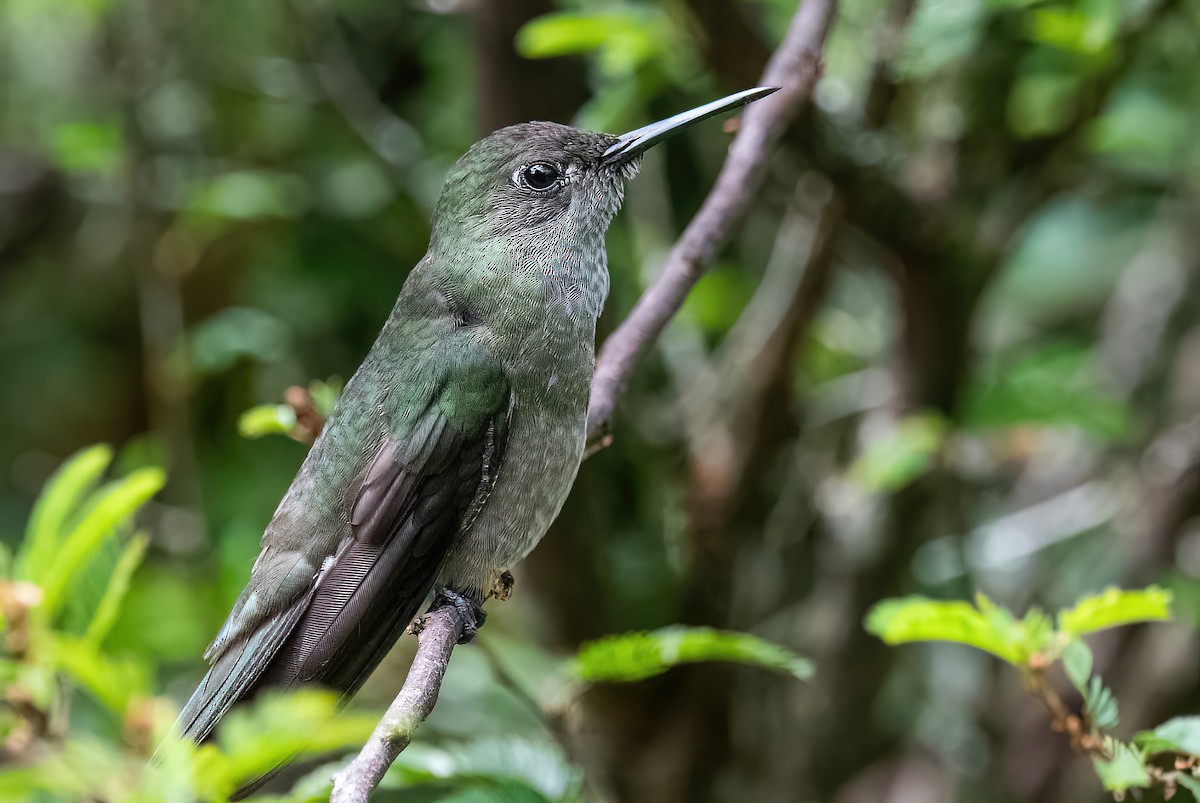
[568,627,812,683]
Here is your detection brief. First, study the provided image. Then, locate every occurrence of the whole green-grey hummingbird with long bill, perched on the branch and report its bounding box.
[178,88,775,758]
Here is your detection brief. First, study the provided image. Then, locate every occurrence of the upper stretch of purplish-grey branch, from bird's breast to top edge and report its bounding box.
[588,0,836,441]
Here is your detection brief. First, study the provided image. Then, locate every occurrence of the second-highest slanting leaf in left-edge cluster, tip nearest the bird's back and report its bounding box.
[42,468,167,619]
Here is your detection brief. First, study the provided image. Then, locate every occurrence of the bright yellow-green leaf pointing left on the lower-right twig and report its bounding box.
[865,594,1054,665]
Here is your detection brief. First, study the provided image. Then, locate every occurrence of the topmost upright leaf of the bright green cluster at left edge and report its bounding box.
[14,444,113,582]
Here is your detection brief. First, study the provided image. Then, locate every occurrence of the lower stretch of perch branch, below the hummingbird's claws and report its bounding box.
[329,603,463,803]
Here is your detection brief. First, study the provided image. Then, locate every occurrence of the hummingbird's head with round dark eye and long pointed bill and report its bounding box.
[433,88,775,248]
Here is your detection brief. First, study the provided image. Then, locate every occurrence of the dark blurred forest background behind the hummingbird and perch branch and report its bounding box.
[0,0,1200,803]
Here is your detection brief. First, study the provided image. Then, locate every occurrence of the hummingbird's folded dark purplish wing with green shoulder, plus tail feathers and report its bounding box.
[180,346,512,741]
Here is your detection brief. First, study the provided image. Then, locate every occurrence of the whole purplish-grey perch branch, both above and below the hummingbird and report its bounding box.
[330,0,836,803]
